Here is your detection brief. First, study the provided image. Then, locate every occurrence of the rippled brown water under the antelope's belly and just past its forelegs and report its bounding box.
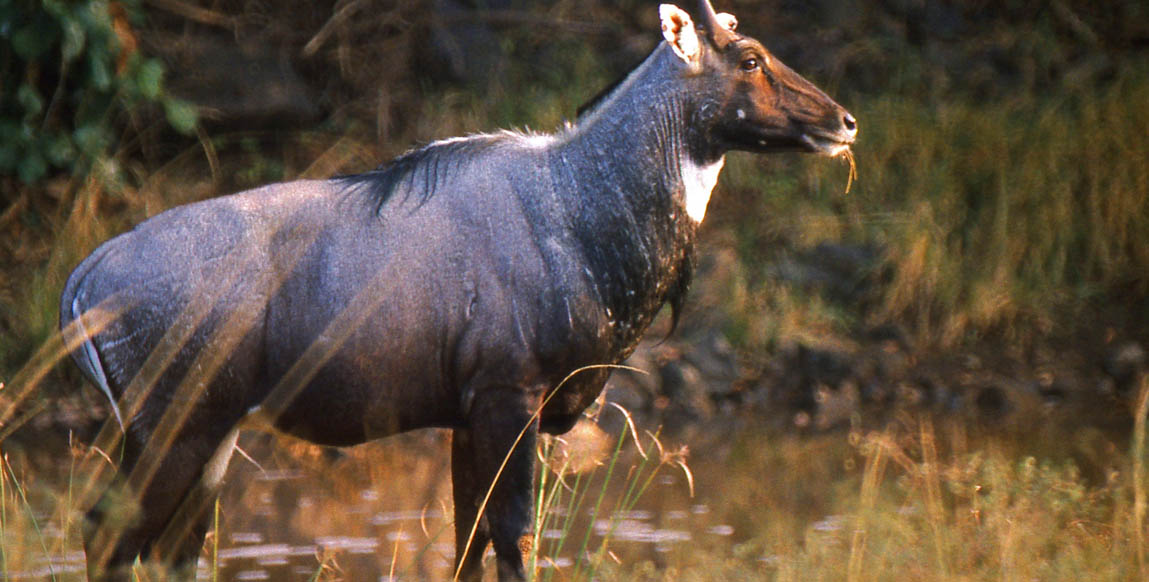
[199,432,738,581]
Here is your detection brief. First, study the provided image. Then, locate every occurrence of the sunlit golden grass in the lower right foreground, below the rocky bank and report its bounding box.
[601,393,1146,582]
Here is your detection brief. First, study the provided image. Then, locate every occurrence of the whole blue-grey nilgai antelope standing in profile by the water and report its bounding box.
[61,0,857,581]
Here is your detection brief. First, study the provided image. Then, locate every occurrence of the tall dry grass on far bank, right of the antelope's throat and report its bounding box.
[717,61,1149,346]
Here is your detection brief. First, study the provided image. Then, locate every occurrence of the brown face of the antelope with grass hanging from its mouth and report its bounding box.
[705,34,857,156]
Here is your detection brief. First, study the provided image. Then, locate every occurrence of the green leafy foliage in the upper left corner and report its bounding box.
[0,0,195,184]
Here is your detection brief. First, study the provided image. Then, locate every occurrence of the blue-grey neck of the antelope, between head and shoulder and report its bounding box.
[553,46,702,357]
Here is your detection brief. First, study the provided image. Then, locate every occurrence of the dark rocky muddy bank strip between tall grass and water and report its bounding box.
[608,327,1147,430]
